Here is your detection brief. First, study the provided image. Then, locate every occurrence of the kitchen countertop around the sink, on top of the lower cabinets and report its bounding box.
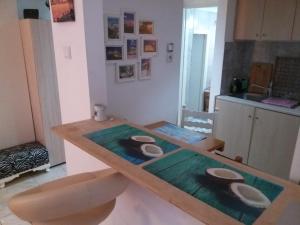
[217,95,300,117]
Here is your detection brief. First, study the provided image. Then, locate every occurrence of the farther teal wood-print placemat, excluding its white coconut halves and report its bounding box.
[84,124,179,165]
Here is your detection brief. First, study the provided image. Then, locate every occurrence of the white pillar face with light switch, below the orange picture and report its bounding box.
[52,0,91,123]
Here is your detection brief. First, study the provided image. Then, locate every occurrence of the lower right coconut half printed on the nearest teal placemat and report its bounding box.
[230,183,271,208]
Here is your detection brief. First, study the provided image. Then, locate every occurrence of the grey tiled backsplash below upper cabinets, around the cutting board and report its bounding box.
[221,41,300,94]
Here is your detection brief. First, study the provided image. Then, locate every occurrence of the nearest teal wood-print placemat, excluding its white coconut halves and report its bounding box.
[144,150,283,225]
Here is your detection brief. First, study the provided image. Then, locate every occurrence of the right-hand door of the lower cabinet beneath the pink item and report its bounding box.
[248,109,300,179]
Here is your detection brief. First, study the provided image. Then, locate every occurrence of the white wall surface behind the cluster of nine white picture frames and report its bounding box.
[104,0,183,124]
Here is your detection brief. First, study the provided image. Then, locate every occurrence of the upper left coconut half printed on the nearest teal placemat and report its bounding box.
[206,168,244,183]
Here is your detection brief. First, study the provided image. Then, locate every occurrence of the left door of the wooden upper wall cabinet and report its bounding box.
[235,0,265,40]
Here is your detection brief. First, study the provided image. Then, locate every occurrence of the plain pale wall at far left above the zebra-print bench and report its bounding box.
[0,0,35,149]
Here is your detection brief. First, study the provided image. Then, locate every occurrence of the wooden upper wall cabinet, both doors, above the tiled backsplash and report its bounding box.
[235,0,297,41]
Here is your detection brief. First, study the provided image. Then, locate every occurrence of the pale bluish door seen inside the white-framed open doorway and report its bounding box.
[185,34,206,112]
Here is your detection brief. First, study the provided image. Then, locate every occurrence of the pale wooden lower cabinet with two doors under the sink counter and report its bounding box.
[214,99,300,179]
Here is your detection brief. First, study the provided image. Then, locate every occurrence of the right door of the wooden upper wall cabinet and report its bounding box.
[262,0,297,41]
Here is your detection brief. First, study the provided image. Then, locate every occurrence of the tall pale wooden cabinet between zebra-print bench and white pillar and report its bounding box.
[20,19,65,166]
